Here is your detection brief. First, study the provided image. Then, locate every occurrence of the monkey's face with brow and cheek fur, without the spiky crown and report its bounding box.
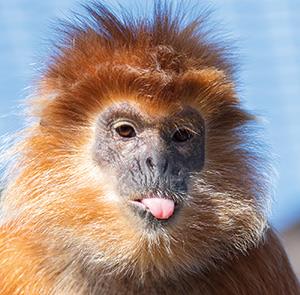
[11,68,265,278]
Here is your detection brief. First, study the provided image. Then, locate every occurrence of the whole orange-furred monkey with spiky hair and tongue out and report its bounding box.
[0,1,300,295]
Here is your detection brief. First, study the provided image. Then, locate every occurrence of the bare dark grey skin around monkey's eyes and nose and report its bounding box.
[93,103,204,225]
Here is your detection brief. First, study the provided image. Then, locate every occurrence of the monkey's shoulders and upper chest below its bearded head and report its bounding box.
[0,224,300,295]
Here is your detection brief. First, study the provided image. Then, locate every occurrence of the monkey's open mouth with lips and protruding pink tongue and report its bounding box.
[129,196,178,221]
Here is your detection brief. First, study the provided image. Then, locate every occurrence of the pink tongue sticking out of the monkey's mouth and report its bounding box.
[141,198,175,219]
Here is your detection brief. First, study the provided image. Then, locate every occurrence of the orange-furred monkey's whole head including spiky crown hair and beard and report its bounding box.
[4,4,267,284]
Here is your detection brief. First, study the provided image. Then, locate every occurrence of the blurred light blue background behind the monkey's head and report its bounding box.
[0,0,300,230]
